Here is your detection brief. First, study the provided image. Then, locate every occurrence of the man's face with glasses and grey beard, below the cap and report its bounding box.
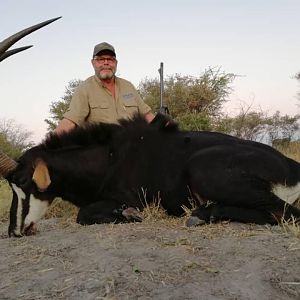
[92,55,118,79]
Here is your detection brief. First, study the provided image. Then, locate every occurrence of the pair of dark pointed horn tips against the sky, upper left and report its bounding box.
[0,17,61,61]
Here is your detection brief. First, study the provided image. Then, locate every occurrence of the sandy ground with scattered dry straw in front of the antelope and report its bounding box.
[0,219,300,300]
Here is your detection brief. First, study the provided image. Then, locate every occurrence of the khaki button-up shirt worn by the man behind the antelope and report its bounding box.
[64,75,151,125]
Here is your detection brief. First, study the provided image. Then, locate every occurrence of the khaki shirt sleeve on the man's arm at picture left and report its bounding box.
[64,85,90,125]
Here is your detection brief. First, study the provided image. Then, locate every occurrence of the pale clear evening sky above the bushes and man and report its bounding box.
[0,0,300,143]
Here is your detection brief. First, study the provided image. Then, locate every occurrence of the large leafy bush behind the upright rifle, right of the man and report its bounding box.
[139,68,235,120]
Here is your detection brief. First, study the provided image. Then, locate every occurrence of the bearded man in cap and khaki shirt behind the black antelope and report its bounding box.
[55,42,154,134]
